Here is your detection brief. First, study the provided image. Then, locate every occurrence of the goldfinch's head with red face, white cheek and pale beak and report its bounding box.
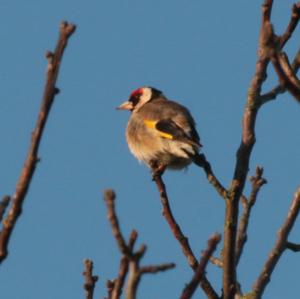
[117,87,162,112]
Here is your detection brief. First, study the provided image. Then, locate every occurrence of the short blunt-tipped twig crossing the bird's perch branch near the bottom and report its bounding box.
[180,234,221,299]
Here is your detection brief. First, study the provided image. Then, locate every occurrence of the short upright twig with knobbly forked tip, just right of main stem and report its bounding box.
[236,167,267,264]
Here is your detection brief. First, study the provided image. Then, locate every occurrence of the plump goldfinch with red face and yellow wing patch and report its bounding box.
[117,86,202,178]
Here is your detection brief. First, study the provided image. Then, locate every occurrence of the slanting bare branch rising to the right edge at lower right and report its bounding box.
[253,188,300,299]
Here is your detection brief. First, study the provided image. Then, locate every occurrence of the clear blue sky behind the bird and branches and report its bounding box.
[0,0,300,299]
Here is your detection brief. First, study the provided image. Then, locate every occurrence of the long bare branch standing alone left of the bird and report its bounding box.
[0,22,76,263]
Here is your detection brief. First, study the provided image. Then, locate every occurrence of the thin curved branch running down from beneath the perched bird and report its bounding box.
[153,175,219,299]
